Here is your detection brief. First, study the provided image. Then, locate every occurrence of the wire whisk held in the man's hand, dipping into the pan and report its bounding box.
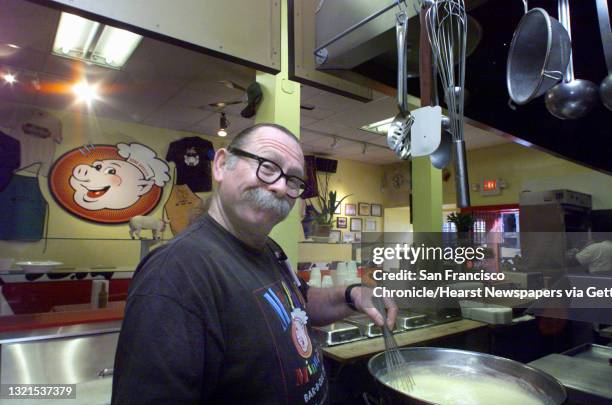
[372,297,414,392]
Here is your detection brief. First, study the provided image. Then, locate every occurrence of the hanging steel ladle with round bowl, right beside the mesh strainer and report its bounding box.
[544,0,598,120]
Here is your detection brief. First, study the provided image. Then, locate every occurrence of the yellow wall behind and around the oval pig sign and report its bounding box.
[0,103,223,270]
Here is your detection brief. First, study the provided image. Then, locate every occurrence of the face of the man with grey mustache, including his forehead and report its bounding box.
[215,127,304,234]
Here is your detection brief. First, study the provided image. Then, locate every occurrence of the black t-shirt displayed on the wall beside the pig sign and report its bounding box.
[166,136,215,193]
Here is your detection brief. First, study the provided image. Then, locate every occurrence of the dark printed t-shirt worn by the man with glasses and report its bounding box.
[112,215,328,405]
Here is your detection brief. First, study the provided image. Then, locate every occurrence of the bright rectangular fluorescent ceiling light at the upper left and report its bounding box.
[53,13,142,69]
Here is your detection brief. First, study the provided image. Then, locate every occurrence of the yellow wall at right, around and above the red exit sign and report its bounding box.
[443,143,612,209]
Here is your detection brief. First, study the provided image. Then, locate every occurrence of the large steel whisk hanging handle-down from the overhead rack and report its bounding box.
[425,0,470,207]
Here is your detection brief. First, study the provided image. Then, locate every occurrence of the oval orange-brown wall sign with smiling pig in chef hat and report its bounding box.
[49,143,170,223]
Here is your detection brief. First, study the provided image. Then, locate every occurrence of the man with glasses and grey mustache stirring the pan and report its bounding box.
[112,124,397,405]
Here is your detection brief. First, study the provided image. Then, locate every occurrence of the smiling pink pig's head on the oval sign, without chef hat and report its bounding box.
[70,159,155,211]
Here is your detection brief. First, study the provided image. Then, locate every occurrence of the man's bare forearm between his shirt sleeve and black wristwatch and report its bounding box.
[306,287,354,326]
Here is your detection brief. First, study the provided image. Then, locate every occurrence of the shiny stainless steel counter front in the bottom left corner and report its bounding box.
[0,321,121,405]
